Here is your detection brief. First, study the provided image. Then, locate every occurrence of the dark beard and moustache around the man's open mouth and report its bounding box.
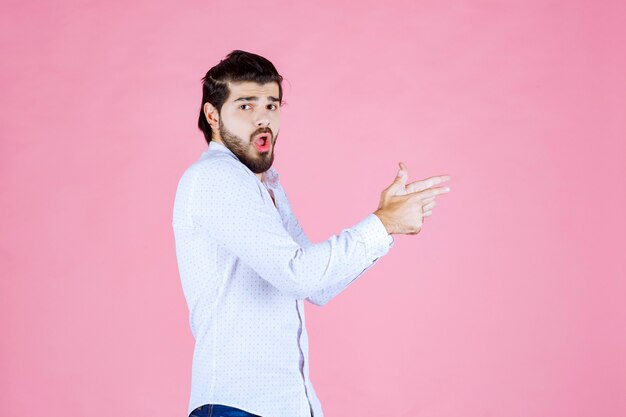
[219,118,278,174]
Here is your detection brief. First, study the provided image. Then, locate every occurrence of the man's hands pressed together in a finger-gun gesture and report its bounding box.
[374,162,451,235]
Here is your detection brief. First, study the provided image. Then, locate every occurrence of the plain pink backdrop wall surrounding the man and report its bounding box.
[0,0,626,417]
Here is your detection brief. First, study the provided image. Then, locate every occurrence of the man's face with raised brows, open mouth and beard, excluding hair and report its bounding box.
[213,81,280,174]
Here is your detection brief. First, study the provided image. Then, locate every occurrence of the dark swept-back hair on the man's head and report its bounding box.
[198,50,283,143]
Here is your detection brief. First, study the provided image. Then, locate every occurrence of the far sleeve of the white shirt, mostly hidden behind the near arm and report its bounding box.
[279,182,394,306]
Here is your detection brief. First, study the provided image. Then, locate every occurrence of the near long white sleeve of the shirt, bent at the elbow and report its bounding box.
[181,158,389,299]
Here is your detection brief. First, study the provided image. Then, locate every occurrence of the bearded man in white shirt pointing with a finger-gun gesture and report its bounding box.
[173,51,450,417]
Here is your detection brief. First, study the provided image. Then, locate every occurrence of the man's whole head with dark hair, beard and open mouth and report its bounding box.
[198,50,283,174]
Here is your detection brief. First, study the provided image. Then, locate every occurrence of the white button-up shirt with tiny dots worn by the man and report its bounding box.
[172,141,394,417]
